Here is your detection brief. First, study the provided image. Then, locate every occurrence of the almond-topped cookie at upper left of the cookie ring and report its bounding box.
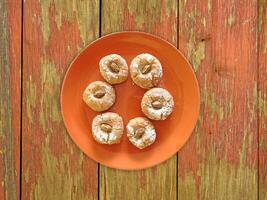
[99,54,128,85]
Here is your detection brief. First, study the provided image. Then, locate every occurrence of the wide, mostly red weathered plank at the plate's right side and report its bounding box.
[178,0,258,200]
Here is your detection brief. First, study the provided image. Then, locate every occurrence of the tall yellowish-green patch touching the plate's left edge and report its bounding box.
[40,58,61,131]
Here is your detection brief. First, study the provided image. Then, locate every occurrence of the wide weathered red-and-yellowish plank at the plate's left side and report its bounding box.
[22,0,99,199]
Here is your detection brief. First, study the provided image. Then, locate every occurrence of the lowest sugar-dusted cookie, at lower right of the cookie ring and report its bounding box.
[126,117,156,149]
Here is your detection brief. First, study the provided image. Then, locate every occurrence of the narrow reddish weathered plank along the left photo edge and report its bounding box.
[0,0,21,199]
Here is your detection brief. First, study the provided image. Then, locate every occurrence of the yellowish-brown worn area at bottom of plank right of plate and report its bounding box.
[178,122,257,200]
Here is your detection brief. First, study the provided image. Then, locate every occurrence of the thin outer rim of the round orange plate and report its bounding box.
[60,31,200,171]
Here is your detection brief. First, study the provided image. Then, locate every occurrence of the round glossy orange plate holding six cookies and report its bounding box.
[61,32,199,170]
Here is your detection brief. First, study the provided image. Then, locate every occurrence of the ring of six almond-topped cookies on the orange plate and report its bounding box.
[83,53,174,149]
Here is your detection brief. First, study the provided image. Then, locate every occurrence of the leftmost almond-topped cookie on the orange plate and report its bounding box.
[83,81,116,112]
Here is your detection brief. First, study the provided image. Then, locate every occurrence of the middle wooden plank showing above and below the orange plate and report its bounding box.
[99,0,177,200]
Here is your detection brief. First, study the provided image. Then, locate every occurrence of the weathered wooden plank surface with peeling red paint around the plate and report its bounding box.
[0,0,267,200]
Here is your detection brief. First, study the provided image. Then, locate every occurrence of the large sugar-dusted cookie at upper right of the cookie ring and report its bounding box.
[130,53,163,89]
